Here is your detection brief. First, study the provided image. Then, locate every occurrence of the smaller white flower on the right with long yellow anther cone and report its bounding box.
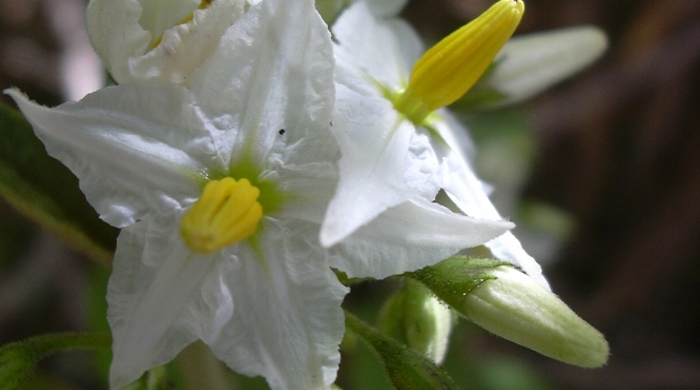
[321,0,548,287]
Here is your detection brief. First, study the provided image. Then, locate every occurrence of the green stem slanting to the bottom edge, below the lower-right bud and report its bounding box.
[345,311,457,390]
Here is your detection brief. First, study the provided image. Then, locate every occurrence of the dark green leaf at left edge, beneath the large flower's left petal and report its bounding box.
[0,104,118,265]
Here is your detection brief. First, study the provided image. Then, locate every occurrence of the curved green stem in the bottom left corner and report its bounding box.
[0,333,112,390]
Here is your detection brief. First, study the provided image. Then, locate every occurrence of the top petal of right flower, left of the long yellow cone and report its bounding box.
[333,2,423,90]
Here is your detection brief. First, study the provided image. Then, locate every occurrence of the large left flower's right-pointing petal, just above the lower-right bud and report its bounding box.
[330,200,513,279]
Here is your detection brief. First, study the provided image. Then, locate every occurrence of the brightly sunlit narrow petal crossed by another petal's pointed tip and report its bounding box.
[442,154,549,289]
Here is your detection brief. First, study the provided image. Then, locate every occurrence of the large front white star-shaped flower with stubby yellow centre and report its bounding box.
[8,0,512,389]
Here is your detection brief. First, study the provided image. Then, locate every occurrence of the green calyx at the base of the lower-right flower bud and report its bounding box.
[406,256,510,312]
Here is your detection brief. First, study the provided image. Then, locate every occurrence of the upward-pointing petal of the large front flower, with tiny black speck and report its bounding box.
[192,0,337,174]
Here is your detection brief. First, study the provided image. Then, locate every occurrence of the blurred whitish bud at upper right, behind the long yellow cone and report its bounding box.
[483,26,608,107]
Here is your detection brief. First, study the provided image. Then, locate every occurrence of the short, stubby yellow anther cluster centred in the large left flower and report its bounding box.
[180,177,263,254]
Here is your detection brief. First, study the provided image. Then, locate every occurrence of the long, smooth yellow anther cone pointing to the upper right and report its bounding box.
[395,0,525,123]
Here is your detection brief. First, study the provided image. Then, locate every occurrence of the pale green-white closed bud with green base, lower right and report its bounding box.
[410,257,609,368]
